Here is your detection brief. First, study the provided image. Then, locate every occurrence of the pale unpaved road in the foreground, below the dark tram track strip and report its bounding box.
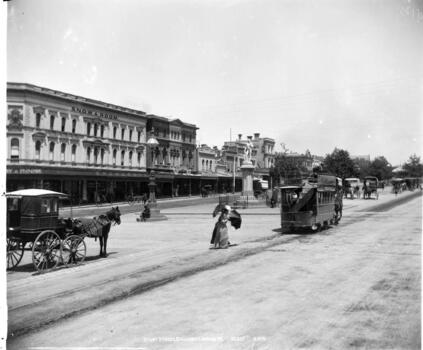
[8,193,422,349]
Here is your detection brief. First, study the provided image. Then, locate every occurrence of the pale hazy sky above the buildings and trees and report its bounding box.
[7,0,423,165]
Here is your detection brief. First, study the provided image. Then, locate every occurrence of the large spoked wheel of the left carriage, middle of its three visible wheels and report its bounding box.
[32,231,62,271]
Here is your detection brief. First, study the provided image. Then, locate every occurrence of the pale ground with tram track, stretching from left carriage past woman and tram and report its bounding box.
[8,192,421,337]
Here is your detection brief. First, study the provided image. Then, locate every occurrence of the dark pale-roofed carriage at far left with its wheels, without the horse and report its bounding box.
[6,189,86,271]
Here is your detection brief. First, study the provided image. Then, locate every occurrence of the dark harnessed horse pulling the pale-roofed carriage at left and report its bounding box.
[73,207,121,257]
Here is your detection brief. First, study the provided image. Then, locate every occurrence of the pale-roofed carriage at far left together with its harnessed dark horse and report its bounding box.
[6,189,120,272]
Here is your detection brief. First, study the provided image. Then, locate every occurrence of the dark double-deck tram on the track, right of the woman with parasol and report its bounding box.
[280,175,342,233]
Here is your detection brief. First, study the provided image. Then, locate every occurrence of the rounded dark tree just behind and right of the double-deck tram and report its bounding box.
[323,148,360,179]
